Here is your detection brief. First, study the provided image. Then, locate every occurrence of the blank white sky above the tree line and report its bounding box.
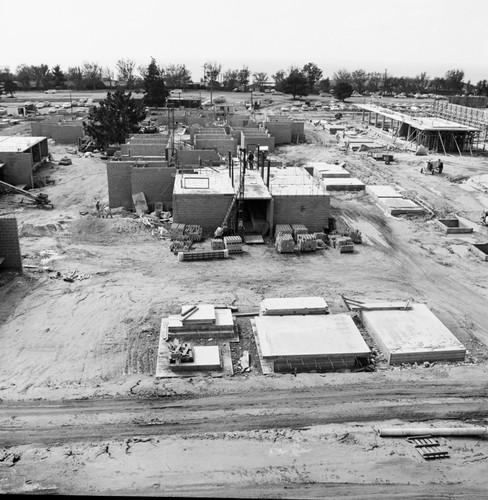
[0,0,488,83]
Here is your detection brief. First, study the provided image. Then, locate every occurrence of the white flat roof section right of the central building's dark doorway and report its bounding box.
[269,167,329,196]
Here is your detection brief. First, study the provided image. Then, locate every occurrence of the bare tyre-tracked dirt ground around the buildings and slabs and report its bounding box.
[0,104,488,498]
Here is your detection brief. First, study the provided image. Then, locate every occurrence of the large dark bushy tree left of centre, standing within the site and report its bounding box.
[83,90,146,149]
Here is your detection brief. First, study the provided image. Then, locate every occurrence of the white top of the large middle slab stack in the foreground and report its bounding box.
[255,314,370,358]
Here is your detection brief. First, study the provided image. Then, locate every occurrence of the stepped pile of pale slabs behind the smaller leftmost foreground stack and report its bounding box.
[166,304,234,338]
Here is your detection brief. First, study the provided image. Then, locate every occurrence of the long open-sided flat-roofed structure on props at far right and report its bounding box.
[357,102,488,155]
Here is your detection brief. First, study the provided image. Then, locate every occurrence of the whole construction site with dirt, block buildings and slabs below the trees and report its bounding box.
[0,93,488,498]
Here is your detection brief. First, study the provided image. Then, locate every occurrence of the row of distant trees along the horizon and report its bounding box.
[0,58,488,97]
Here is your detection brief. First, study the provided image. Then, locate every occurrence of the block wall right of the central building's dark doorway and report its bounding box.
[273,195,330,232]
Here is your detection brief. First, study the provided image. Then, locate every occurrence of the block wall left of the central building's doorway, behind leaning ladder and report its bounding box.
[173,193,233,234]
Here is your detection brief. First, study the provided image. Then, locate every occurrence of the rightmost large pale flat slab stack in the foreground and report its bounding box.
[360,304,466,364]
